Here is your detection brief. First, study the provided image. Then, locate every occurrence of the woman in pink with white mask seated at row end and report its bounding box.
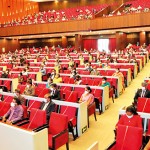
[79,86,94,106]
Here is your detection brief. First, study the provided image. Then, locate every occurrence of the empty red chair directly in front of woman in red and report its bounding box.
[107,125,143,150]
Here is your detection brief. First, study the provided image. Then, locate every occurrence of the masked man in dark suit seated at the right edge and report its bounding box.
[134,82,150,105]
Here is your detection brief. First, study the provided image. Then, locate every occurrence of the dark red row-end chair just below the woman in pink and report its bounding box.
[87,102,97,128]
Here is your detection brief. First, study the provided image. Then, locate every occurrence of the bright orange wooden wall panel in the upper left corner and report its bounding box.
[0,0,39,24]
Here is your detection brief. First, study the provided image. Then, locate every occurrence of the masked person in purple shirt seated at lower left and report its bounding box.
[2,97,23,124]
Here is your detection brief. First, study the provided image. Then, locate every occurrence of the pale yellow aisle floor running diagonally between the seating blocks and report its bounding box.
[59,62,150,150]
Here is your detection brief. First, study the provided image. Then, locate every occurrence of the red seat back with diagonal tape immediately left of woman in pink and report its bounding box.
[65,91,78,102]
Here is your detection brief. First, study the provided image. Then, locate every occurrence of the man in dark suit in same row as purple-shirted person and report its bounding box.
[40,94,55,121]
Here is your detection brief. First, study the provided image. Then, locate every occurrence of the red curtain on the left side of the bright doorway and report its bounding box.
[83,39,98,50]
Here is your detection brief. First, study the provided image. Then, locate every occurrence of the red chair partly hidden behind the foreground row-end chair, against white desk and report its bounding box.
[60,106,78,140]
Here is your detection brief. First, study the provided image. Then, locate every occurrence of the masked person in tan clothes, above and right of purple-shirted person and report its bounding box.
[23,80,35,96]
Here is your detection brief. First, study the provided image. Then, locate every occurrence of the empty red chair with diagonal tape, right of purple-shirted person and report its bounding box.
[17,108,46,131]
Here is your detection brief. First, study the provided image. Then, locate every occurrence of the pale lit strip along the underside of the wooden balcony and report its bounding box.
[2,27,150,40]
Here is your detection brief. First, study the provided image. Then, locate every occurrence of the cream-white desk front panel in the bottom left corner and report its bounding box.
[0,122,48,150]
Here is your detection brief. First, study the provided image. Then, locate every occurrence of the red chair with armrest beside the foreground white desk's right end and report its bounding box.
[48,112,69,150]
